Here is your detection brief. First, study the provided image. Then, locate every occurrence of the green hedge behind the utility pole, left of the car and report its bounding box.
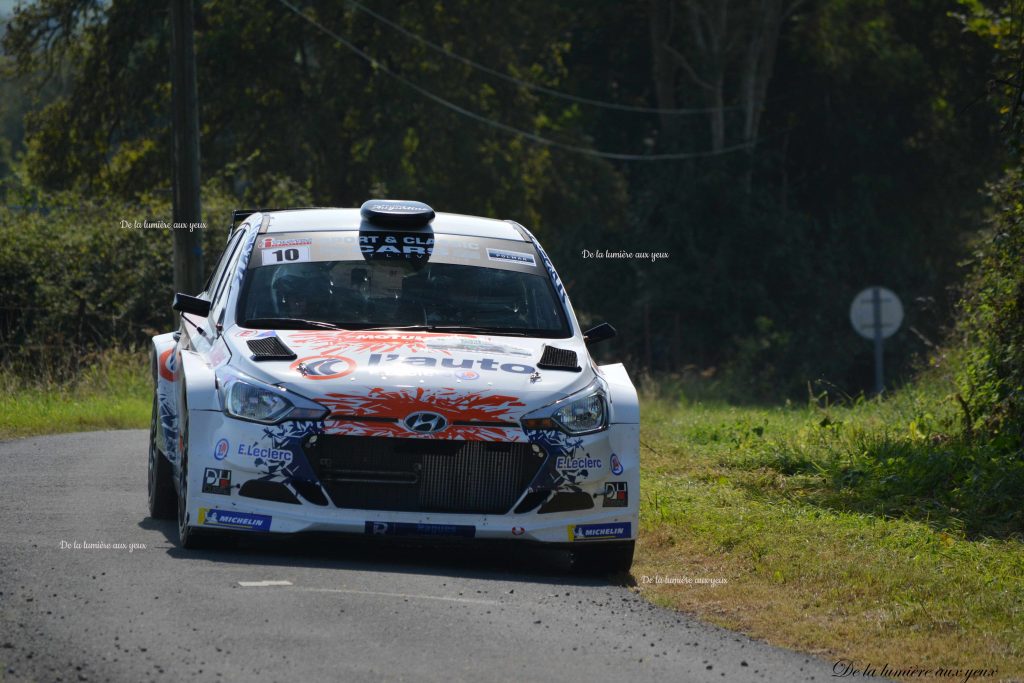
[0,184,232,379]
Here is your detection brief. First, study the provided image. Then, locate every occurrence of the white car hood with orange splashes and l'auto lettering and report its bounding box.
[223,327,594,421]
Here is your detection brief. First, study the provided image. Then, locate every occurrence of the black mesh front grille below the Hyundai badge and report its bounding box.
[305,435,544,514]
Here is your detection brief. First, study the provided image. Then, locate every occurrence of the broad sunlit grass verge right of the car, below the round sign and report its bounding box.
[633,375,1024,680]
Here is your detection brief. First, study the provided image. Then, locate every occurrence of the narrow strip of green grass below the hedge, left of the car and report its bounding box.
[0,351,153,439]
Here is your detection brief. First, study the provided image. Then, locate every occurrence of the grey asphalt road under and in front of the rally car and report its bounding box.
[0,431,831,683]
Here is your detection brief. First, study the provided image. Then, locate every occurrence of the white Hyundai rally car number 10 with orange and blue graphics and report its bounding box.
[148,200,640,571]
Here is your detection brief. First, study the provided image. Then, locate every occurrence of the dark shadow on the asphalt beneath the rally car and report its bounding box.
[138,518,636,587]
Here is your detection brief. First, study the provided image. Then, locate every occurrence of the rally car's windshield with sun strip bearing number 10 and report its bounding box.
[237,233,571,338]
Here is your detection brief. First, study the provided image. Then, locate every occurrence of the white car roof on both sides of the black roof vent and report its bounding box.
[256,209,526,242]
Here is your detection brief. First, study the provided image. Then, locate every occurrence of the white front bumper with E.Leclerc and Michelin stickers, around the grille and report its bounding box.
[186,411,640,544]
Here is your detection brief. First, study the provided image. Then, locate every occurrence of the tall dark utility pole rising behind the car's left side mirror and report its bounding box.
[170,0,203,295]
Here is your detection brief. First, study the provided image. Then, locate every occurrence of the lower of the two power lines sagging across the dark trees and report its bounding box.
[278,0,753,161]
